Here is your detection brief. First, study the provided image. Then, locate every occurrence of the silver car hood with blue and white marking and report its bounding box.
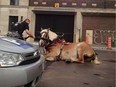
[0,36,38,53]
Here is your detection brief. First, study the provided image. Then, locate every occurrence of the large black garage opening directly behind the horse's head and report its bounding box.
[35,13,74,42]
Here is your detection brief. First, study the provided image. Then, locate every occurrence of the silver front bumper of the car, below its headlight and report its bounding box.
[0,55,44,87]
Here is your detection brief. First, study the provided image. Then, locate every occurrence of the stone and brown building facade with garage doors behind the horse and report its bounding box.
[0,0,116,44]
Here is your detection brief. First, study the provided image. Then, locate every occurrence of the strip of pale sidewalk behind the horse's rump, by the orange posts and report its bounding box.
[91,44,116,51]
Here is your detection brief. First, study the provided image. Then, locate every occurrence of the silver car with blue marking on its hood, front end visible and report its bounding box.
[0,36,44,87]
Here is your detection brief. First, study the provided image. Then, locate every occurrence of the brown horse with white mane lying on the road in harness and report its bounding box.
[40,29,101,64]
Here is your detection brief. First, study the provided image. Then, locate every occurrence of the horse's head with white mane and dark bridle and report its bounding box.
[39,28,58,46]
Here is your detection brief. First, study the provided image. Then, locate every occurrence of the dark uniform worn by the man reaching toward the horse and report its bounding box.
[11,21,29,40]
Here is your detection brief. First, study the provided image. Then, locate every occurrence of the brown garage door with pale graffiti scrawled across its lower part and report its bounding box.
[83,13,116,44]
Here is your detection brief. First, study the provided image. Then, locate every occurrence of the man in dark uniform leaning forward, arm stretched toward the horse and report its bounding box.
[7,18,35,40]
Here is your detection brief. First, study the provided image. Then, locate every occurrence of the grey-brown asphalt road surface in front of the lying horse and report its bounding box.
[38,51,116,87]
